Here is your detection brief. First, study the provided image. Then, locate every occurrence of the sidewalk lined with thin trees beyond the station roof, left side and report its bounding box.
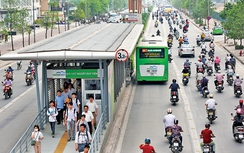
[0,23,75,68]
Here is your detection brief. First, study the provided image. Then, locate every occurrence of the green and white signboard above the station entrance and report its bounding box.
[47,69,103,79]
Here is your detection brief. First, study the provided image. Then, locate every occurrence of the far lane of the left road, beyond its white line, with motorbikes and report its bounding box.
[0,61,42,108]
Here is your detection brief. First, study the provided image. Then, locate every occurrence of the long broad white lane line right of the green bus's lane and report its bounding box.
[166,16,202,153]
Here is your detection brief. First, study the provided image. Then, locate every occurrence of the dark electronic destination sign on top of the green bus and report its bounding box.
[140,48,164,58]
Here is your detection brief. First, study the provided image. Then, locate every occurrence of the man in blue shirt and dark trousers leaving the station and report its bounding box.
[55,90,65,124]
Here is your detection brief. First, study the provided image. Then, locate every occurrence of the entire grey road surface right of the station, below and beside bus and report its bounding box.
[117,8,244,153]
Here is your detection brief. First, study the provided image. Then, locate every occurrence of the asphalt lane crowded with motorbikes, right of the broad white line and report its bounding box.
[174,20,243,152]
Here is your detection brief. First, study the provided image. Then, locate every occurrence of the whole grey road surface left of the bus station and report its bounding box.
[0,61,41,153]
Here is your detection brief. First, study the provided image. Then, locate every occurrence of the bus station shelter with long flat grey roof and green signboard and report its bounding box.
[0,23,143,152]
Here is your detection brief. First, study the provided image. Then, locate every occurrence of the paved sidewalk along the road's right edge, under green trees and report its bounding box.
[182,13,244,65]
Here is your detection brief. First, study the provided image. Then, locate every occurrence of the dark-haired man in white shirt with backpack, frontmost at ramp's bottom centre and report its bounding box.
[75,124,92,153]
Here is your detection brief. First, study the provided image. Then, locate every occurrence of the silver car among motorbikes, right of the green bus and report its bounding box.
[178,42,195,57]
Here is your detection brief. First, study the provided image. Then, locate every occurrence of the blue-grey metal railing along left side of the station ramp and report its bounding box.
[10,108,47,153]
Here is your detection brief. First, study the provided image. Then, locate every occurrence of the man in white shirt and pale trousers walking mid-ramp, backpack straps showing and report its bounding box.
[65,102,77,141]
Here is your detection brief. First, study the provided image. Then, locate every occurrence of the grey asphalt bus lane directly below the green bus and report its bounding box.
[121,65,193,153]
